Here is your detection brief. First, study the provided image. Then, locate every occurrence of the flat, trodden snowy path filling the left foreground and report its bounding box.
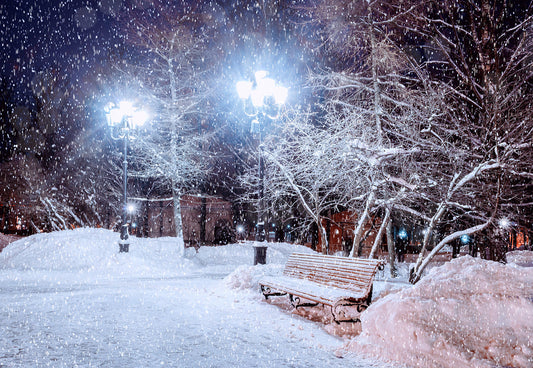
[0,275,390,367]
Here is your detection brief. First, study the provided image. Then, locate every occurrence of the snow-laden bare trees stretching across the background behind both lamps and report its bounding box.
[2,0,533,282]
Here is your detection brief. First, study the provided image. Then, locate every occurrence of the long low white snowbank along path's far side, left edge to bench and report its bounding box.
[0,228,311,282]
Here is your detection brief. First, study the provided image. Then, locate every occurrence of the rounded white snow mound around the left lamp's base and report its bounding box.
[0,228,190,276]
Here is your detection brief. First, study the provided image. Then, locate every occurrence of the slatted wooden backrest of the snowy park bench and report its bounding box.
[283,253,384,293]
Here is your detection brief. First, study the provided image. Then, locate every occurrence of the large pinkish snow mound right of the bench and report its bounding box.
[347,256,533,368]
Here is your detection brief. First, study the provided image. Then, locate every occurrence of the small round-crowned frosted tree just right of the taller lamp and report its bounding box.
[262,113,354,251]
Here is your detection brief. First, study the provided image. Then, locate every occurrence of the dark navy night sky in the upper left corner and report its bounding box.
[0,0,124,102]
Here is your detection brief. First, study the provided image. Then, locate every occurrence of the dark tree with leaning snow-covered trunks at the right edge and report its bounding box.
[404,0,533,282]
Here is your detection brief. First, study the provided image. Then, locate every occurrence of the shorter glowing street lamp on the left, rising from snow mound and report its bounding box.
[105,101,148,253]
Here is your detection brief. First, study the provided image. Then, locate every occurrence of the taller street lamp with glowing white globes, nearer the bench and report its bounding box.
[236,70,288,242]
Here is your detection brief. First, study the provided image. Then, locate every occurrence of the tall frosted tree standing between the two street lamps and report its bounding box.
[118,2,218,247]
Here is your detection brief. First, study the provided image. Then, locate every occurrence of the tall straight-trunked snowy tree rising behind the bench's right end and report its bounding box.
[302,0,442,256]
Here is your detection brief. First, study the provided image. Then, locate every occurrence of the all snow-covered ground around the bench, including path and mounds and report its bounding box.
[0,229,533,368]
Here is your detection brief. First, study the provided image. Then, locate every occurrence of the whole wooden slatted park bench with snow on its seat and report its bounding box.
[259,253,384,323]
